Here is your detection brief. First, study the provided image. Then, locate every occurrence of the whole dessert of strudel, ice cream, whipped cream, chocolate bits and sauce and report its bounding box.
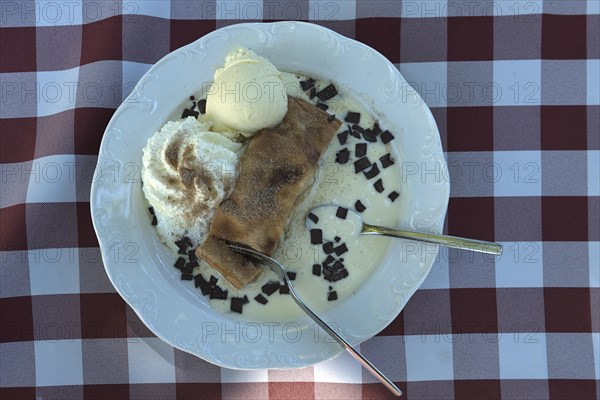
[142,50,406,321]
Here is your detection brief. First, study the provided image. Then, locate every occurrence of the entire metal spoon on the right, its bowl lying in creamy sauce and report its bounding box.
[306,204,502,256]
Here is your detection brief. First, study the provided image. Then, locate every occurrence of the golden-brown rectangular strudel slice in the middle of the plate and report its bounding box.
[198,97,341,287]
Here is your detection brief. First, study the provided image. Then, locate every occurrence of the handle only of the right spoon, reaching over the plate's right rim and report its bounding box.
[361,224,502,256]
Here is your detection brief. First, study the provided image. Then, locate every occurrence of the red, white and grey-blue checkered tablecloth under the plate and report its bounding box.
[0,0,600,400]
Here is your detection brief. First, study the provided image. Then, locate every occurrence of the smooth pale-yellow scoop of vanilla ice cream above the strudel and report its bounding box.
[206,49,287,136]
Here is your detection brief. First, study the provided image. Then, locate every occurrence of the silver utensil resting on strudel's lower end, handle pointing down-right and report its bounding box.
[229,244,402,396]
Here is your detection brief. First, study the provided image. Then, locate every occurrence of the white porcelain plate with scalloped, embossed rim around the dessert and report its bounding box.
[91,22,449,369]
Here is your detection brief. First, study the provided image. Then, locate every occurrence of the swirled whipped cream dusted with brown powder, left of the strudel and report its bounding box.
[142,117,241,252]
